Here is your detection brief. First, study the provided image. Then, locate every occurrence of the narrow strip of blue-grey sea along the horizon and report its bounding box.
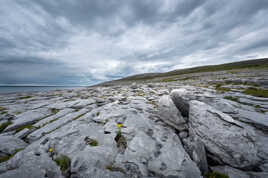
[0,86,85,93]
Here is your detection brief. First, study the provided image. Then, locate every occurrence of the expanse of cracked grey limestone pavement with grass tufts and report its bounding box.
[0,69,268,178]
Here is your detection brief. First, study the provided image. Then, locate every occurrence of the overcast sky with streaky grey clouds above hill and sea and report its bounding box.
[0,0,268,85]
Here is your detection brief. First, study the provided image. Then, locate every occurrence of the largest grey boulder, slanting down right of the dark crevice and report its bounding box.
[189,100,261,170]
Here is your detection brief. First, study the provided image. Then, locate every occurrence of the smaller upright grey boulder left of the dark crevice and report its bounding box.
[159,95,186,131]
